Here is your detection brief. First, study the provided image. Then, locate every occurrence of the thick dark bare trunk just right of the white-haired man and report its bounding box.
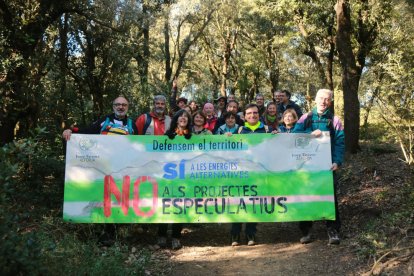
[335,0,360,153]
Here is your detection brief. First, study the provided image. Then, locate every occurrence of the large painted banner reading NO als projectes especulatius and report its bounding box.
[63,132,335,223]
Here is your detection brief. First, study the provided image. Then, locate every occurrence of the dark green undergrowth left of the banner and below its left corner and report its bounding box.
[0,128,149,275]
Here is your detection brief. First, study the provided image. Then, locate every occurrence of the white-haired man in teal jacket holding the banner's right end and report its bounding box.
[293,89,345,244]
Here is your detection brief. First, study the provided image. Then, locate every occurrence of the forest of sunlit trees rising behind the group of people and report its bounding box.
[0,0,413,163]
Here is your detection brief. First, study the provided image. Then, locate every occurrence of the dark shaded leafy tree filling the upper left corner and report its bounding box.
[0,0,82,145]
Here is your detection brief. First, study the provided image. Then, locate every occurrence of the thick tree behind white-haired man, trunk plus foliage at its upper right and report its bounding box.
[335,0,390,153]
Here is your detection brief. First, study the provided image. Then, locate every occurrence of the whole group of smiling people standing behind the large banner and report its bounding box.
[63,87,344,249]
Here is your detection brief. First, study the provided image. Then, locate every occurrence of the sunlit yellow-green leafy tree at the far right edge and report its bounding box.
[362,1,414,166]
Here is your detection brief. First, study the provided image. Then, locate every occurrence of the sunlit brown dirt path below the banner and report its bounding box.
[145,222,366,275]
